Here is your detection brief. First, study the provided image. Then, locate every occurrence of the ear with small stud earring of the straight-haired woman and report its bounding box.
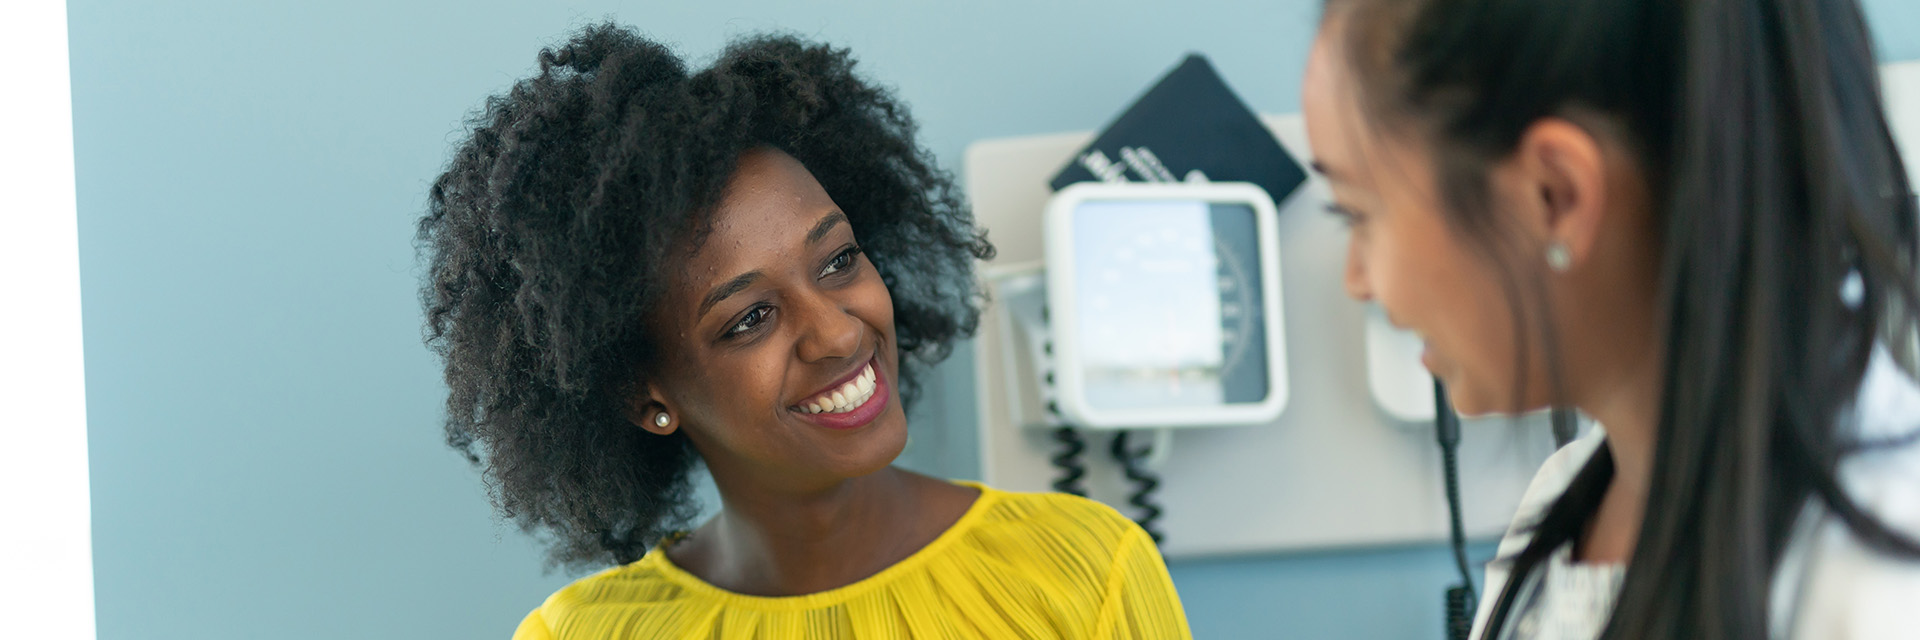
[1513,117,1607,271]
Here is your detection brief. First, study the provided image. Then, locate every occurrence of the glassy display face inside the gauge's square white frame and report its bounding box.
[1064,200,1269,409]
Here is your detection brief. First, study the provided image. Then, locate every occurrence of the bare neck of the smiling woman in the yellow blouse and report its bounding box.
[668,467,972,596]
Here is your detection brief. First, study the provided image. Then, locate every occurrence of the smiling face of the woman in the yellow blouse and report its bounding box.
[636,148,906,488]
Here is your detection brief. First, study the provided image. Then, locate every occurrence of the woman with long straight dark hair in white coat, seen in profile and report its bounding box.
[1302,0,1920,640]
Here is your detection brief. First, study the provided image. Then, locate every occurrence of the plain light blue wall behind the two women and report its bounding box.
[71,0,1920,640]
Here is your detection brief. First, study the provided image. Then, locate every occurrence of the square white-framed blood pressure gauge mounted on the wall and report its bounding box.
[1044,183,1286,429]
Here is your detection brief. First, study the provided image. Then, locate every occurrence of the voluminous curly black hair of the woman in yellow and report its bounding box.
[419,23,993,569]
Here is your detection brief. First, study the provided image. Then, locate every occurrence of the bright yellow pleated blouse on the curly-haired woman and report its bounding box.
[513,482,1192,640]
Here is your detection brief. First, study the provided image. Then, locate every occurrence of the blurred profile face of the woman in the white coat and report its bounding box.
[1302,17,1548,415]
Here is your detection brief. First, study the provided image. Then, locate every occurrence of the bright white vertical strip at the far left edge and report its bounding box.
[0,0,94,640]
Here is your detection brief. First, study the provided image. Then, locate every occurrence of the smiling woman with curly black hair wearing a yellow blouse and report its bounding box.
[420,25,1187,638]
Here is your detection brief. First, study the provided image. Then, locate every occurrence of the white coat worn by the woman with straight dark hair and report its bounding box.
[1473,348,1920,640]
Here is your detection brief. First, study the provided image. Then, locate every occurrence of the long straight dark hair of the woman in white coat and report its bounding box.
[1329,0,1920,640]
